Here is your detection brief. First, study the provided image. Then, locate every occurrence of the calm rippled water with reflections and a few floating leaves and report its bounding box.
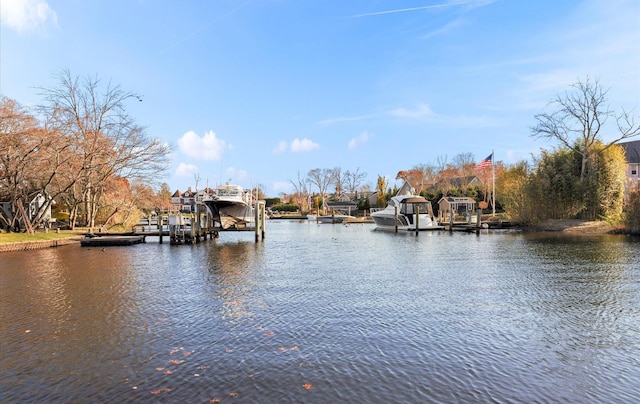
[0,221,640,403]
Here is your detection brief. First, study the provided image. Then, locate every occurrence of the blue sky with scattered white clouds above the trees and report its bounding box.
[0,0,640,197]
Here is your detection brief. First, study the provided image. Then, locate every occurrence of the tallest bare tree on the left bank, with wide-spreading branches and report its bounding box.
[40,70,170,227]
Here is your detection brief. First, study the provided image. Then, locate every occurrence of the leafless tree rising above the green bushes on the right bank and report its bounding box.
[531,77,640,182]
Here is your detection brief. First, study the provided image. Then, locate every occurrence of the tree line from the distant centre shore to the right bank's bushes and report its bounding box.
[291,78,640,233]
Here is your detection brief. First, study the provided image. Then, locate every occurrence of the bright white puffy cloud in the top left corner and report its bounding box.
[0,0,58,33]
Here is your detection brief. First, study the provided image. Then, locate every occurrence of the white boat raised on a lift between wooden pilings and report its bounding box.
[203,182,255,230]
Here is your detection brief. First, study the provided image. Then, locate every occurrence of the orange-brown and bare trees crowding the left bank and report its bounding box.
[0,70,170,231]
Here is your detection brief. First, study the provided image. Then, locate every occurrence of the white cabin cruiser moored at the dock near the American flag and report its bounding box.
[371,182,444,230]
